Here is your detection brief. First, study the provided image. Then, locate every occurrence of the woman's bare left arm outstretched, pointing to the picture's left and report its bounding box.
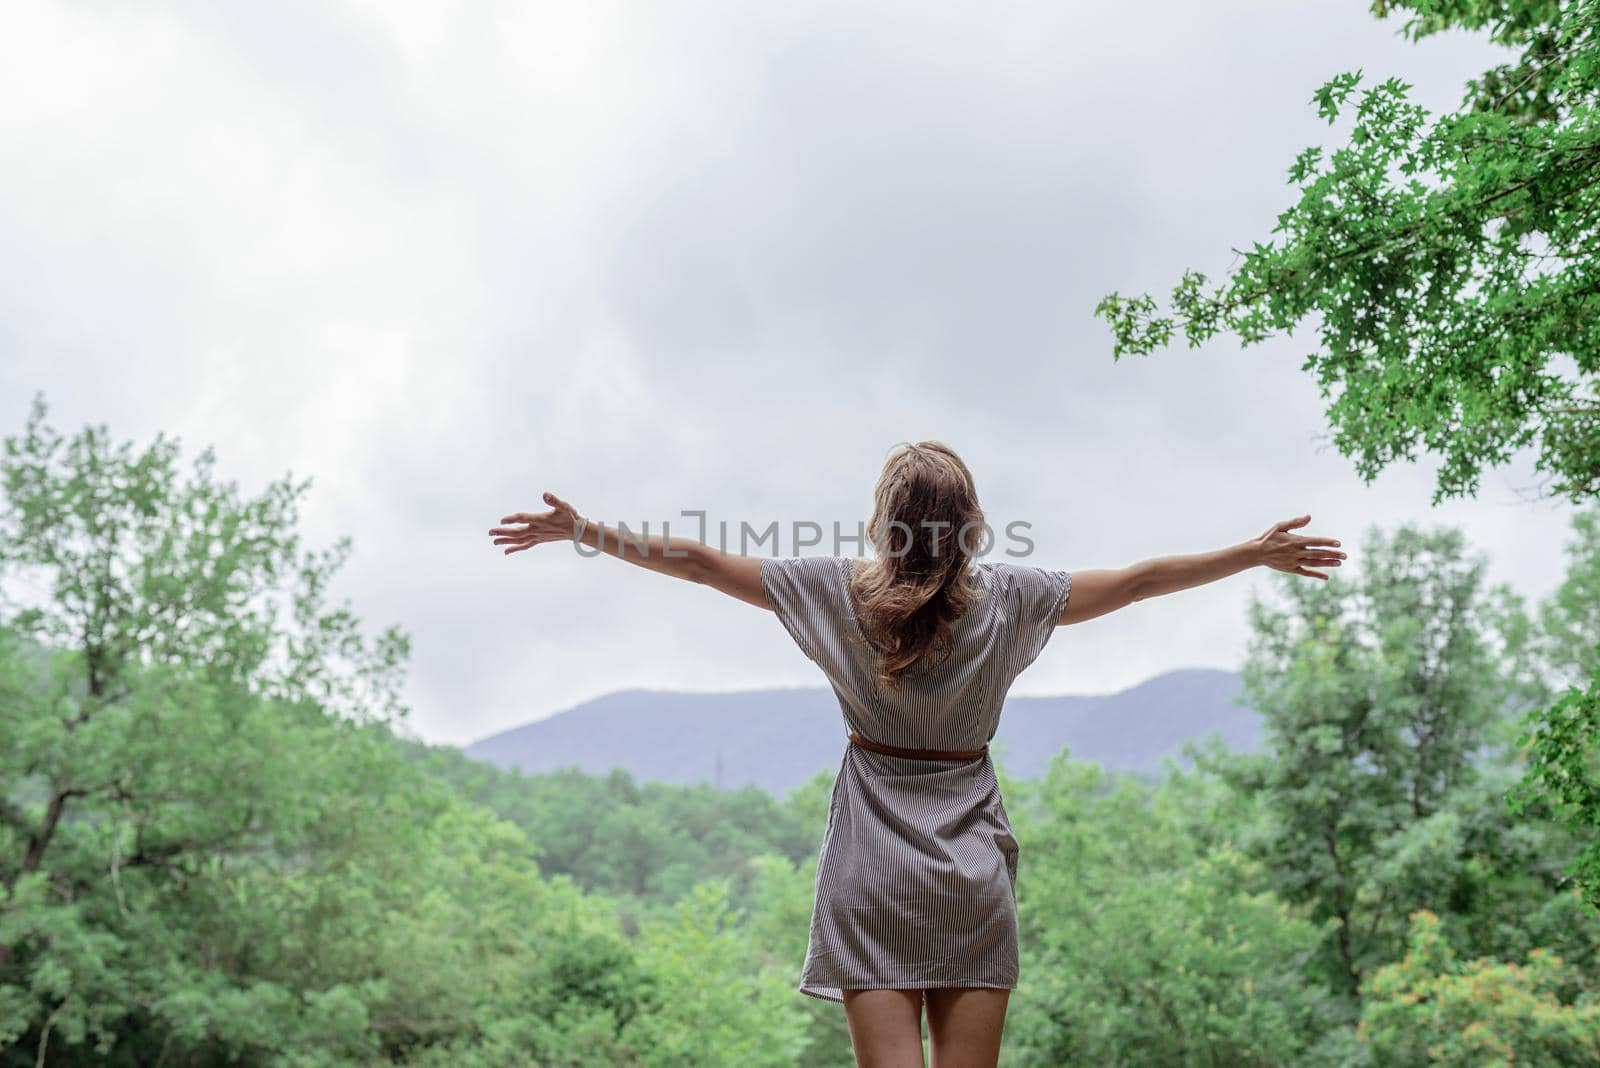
[490,492,773,611]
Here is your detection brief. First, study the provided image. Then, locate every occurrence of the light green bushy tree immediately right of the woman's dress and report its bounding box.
[1002,755,1338,1068]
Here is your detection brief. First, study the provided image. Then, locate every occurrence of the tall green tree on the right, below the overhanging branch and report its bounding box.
[1216,528,1557,999]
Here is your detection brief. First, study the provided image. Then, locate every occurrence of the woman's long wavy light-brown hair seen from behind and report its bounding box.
[850,441,986,689]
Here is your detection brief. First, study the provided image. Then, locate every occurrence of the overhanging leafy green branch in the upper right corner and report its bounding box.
[1096,0,1600,504]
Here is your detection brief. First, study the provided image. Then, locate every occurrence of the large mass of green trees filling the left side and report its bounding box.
[0,401,684,1068]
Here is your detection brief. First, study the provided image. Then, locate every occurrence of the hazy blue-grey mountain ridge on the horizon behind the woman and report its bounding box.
[466,668,1261,796]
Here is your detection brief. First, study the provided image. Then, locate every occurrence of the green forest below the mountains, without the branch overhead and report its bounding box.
[0,400,1600,1068]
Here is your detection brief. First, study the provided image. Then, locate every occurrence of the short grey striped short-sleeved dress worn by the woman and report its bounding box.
[760,556,1072,1002]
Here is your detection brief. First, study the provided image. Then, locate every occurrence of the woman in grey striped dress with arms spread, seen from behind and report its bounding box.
[490,441,1344,1068]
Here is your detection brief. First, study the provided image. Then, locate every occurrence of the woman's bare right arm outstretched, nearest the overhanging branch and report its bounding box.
[1058,515,1344,624]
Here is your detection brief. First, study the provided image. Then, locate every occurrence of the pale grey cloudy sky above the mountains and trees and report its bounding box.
[0,0,1570,742]
